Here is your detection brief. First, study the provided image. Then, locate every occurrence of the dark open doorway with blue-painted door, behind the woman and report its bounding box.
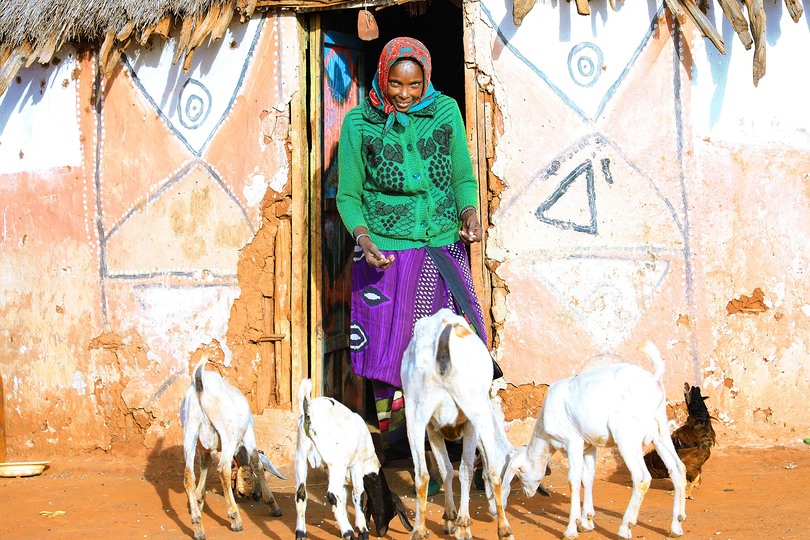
[310,0,465,424]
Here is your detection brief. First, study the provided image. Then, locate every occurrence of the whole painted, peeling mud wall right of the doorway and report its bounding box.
[472,0,810,444]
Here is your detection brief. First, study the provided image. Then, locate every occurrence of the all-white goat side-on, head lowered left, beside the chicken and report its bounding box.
[505,341,686,540]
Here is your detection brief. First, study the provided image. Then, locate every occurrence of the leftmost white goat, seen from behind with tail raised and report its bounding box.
[180,354,285,540]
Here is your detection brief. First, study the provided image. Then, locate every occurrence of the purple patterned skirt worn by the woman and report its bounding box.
[350,241,486,388]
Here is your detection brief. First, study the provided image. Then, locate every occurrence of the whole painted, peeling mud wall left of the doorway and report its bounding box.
[0,16,299,459]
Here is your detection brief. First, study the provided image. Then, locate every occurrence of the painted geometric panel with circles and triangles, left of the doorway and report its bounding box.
[97,18,290,358]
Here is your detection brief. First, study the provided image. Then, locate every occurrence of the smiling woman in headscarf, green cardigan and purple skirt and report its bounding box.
[337,37,486,470]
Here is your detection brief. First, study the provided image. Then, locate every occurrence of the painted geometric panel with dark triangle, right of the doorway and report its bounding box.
[483,2,697,388]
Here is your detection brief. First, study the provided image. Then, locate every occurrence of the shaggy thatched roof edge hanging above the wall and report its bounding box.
[0,0,803,95]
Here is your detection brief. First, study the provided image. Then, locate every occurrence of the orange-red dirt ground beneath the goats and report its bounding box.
[0,445,810,540]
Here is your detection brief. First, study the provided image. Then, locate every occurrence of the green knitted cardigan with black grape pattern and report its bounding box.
[337,95,478,250]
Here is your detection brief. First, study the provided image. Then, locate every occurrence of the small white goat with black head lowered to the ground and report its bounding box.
[295,379,413,540]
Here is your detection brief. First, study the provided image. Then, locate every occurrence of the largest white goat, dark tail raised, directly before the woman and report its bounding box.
[401,308,514,540]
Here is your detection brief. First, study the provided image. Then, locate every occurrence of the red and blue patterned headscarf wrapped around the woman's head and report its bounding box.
[368,37,441,132]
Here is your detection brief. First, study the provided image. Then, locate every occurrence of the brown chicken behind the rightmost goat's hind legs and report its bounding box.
[644,383,715,499]
